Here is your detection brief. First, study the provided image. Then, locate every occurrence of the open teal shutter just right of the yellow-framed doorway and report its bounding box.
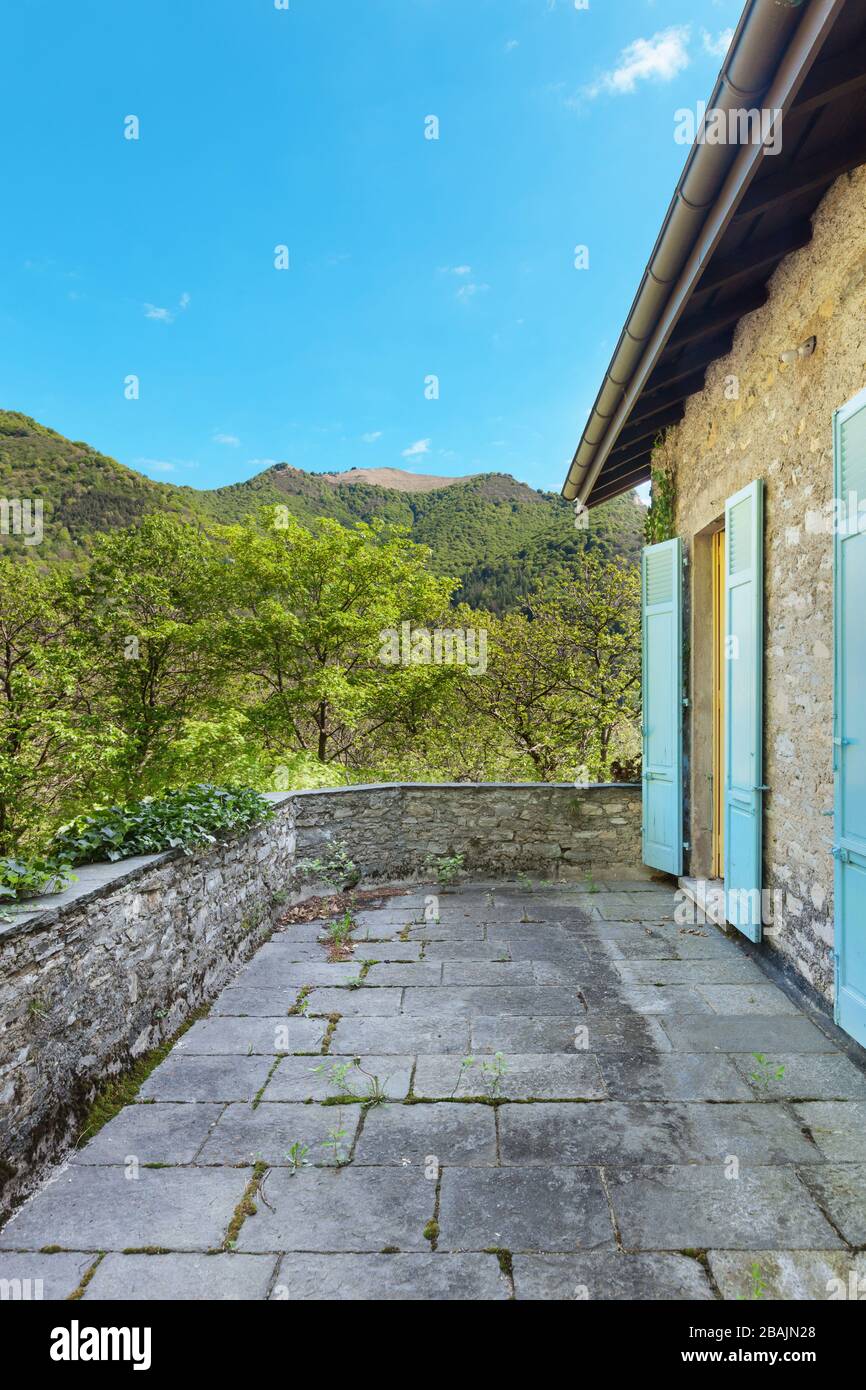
[724,480,766,941]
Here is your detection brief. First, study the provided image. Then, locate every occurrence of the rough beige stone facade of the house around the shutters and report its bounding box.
[655,167,866,999]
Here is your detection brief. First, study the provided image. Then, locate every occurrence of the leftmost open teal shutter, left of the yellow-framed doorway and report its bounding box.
[641,539,683,874]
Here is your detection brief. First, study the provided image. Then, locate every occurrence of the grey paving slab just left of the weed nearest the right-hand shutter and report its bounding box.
[598,1052,755,1102]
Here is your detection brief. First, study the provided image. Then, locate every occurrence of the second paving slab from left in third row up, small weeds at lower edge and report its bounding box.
[199,1093,361,1168]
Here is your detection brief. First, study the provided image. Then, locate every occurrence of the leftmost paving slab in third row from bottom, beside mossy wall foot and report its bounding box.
[71,1104,224,1163]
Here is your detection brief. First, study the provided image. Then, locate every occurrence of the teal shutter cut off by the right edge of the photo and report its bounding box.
[833,392,866,1045]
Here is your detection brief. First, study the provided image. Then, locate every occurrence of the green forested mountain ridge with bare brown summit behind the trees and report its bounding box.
[0,410,645,612]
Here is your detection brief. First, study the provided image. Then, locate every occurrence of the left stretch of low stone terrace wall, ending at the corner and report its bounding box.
[0,805,295,1209]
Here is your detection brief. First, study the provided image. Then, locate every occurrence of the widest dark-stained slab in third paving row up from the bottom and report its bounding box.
[499,1101,822,1166]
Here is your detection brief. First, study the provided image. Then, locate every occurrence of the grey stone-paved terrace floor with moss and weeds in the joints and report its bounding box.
[0,880,866,1301]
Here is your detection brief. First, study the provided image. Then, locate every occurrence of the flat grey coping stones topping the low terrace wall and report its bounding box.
[0,783,641,945]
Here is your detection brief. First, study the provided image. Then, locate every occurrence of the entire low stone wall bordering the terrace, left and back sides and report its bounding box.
[0,784,641,1211]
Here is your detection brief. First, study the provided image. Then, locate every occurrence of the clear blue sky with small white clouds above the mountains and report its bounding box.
[0,0,741,489]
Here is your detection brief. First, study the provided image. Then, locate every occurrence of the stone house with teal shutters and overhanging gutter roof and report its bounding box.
[563,0,866,1044]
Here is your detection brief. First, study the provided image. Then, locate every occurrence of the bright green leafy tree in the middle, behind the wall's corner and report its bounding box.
[220,507,455,766]
